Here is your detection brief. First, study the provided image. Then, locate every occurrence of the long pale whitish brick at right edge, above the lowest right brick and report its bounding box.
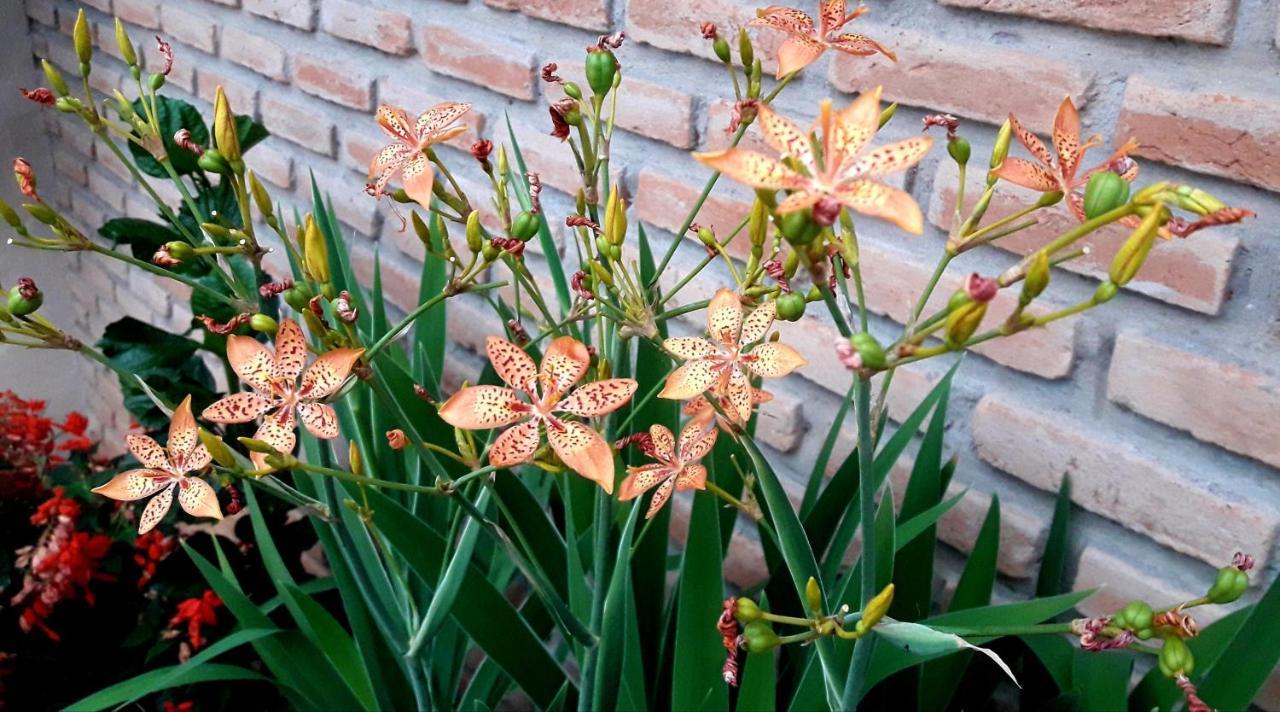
[973,396,1280,566]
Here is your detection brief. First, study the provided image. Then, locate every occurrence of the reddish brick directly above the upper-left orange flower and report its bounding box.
[422,24,535,100]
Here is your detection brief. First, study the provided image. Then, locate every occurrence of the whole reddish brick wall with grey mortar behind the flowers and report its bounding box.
[15,0,1280,660]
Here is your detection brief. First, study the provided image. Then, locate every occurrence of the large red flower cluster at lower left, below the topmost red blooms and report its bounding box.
[12,487,111,640]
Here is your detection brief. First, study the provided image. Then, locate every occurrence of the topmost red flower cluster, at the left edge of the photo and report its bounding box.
[0,391,93,497]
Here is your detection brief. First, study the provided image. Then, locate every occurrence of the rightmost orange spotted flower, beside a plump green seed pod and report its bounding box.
[992,96,1138,222]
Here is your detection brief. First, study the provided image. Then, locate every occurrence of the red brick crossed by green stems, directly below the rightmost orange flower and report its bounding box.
[929,162,1240,314]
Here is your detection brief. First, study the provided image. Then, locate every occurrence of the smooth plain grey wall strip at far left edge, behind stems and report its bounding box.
[0,3,84,417]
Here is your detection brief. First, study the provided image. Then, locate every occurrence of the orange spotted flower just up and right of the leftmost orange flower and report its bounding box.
[201,319,365,467]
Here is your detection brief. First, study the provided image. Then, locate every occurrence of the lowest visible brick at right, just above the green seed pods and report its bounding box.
[1073,546,1225,627]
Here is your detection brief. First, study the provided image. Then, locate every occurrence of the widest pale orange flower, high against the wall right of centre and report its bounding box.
[694,87,932,234]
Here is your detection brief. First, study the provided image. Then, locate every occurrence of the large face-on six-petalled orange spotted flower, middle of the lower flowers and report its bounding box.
[440,337,636,494]
